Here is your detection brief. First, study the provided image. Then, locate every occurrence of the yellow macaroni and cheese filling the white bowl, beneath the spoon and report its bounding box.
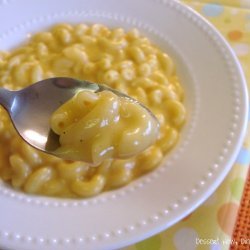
[0,24,186,197]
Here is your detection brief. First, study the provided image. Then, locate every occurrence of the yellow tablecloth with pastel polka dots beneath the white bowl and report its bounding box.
[123,0,250,250]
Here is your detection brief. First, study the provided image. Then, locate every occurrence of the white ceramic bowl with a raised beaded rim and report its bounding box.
[0,0,248,250]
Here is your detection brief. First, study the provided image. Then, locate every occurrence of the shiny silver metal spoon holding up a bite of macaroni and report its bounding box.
[0,77,158,158]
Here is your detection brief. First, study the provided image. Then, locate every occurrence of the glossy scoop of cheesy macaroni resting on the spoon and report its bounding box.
[51,90,159,165]
